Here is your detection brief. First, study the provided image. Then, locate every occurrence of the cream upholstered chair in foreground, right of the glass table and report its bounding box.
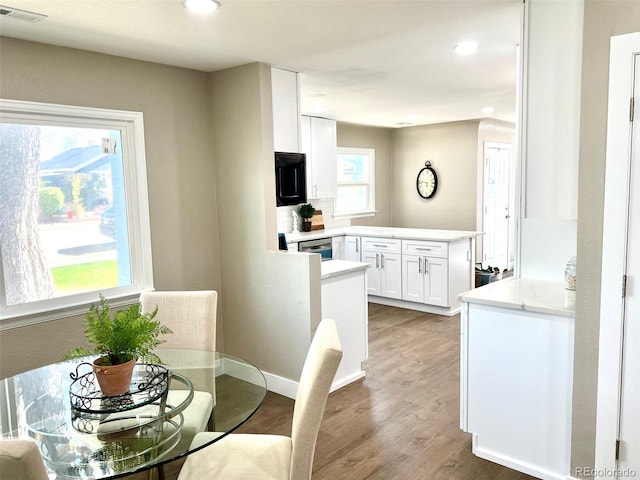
[178,319,342,480]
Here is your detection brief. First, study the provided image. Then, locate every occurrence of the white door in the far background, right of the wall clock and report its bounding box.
[482,142,511,271]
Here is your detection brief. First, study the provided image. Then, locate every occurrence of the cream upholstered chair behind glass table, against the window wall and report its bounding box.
[140,290,218,442]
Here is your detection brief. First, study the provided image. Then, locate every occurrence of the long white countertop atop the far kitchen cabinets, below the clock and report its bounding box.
[285,225,484,243]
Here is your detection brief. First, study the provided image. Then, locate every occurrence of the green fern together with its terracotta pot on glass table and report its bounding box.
[63,295,172,395]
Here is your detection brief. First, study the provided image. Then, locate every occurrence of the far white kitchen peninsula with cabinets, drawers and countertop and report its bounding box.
[286,226,482,316]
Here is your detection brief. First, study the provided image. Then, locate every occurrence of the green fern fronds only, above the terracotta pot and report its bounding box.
[63,295,173,366]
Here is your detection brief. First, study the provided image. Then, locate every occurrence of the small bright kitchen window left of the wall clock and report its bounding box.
[334,147,376,217]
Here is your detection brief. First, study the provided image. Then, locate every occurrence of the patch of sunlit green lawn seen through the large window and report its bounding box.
[51,260,118,293]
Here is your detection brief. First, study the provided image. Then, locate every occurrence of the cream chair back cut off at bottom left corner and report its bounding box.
[0,439,49,480]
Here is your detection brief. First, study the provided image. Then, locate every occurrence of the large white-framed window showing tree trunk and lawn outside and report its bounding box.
[0,100,152,328]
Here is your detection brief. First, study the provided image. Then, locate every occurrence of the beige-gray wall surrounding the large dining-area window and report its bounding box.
[0,37,223,377]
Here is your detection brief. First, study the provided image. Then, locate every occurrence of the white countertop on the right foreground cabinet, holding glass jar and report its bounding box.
[458,278,575,317]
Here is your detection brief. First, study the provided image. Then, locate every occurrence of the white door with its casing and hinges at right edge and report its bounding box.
[596,32,640,479]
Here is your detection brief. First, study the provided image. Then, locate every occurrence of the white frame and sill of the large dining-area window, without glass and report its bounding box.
[0,99,153,331]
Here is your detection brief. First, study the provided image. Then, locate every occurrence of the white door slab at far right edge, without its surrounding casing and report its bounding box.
[618,54,640,477]
